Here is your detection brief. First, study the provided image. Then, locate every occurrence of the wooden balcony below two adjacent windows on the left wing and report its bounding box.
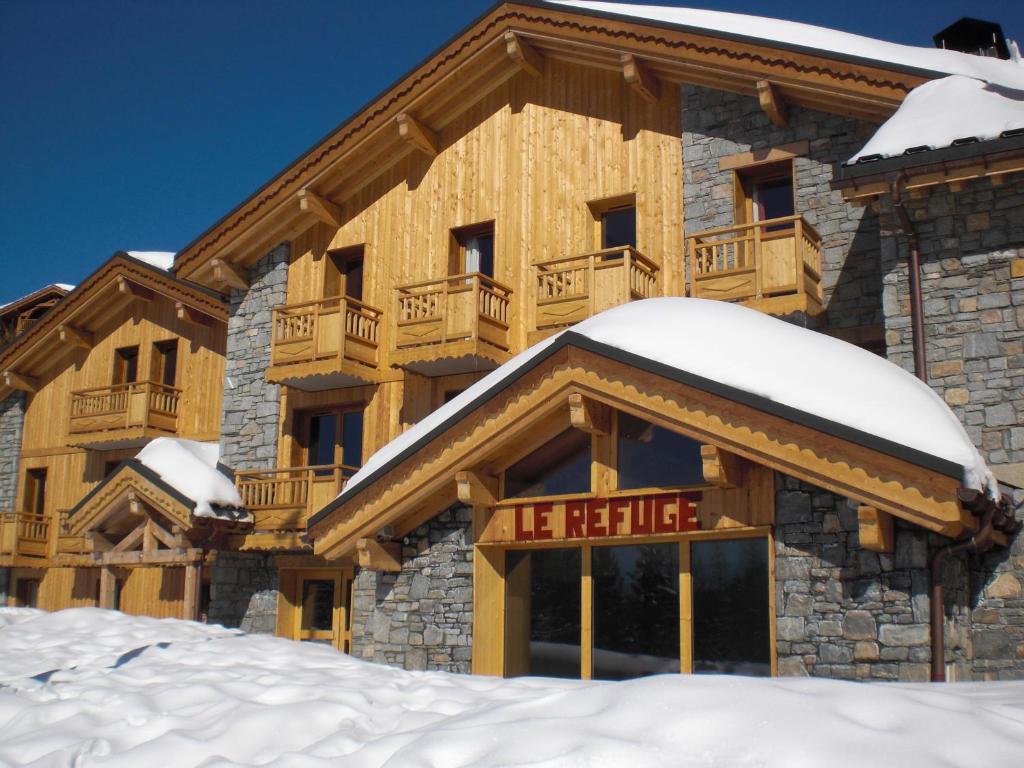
[68,381,181,449]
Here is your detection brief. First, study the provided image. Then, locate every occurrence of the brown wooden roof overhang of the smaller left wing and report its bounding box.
[0,252,227,398]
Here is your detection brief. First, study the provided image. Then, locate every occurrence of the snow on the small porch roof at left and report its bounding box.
[135,437,242,519]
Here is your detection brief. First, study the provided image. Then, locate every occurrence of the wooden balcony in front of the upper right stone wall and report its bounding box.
[687,216,823,314]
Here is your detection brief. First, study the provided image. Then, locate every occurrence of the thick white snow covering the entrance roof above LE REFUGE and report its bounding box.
[343,298,998,505]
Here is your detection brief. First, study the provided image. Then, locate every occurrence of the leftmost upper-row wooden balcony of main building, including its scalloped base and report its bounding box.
[266,296,382,391]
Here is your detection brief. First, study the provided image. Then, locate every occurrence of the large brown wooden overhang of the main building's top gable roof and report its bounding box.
[175,2,942,285]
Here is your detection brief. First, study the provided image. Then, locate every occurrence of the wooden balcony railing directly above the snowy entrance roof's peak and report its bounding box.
[534,246,658,331]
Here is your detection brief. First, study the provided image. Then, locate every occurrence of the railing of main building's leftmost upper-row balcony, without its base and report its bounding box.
[270,296,382,373]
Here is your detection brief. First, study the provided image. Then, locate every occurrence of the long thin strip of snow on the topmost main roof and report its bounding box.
[551,0,1024,89]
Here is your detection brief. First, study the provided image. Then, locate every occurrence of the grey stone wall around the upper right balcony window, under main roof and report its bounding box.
[682,85,882,328]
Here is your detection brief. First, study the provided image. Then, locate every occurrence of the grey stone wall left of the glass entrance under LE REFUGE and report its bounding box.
[352,506,473,674]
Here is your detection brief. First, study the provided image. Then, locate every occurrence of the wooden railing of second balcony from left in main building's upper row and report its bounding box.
[395,272,512,357]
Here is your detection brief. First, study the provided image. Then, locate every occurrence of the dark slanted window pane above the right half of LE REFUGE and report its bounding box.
[618,412,705,489]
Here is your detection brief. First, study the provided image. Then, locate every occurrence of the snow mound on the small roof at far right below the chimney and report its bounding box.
[848,75,1024,164]
